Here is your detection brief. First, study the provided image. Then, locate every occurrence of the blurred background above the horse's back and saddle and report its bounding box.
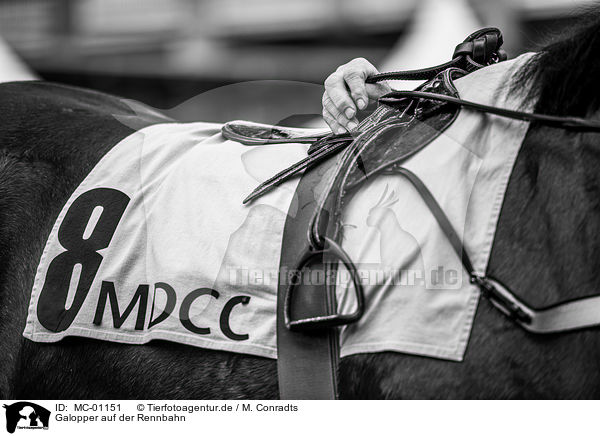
[0,0,594,122]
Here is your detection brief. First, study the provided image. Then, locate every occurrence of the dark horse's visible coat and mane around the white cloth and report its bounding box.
[0,19,600,399]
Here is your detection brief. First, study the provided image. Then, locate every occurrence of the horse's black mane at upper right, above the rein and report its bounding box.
[513,7,600,117]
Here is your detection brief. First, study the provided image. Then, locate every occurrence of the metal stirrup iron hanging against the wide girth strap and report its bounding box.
[283,237,364,331]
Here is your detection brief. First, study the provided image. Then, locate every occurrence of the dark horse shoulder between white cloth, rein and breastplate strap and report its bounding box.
[489,122,600,306]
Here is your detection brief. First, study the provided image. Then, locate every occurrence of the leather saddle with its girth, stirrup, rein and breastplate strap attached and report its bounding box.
[222,28,600,399]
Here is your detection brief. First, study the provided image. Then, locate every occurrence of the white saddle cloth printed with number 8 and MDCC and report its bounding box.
[24,53,528,360]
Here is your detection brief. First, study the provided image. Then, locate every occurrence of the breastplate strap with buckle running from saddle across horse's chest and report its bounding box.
[393,167,600,334]
